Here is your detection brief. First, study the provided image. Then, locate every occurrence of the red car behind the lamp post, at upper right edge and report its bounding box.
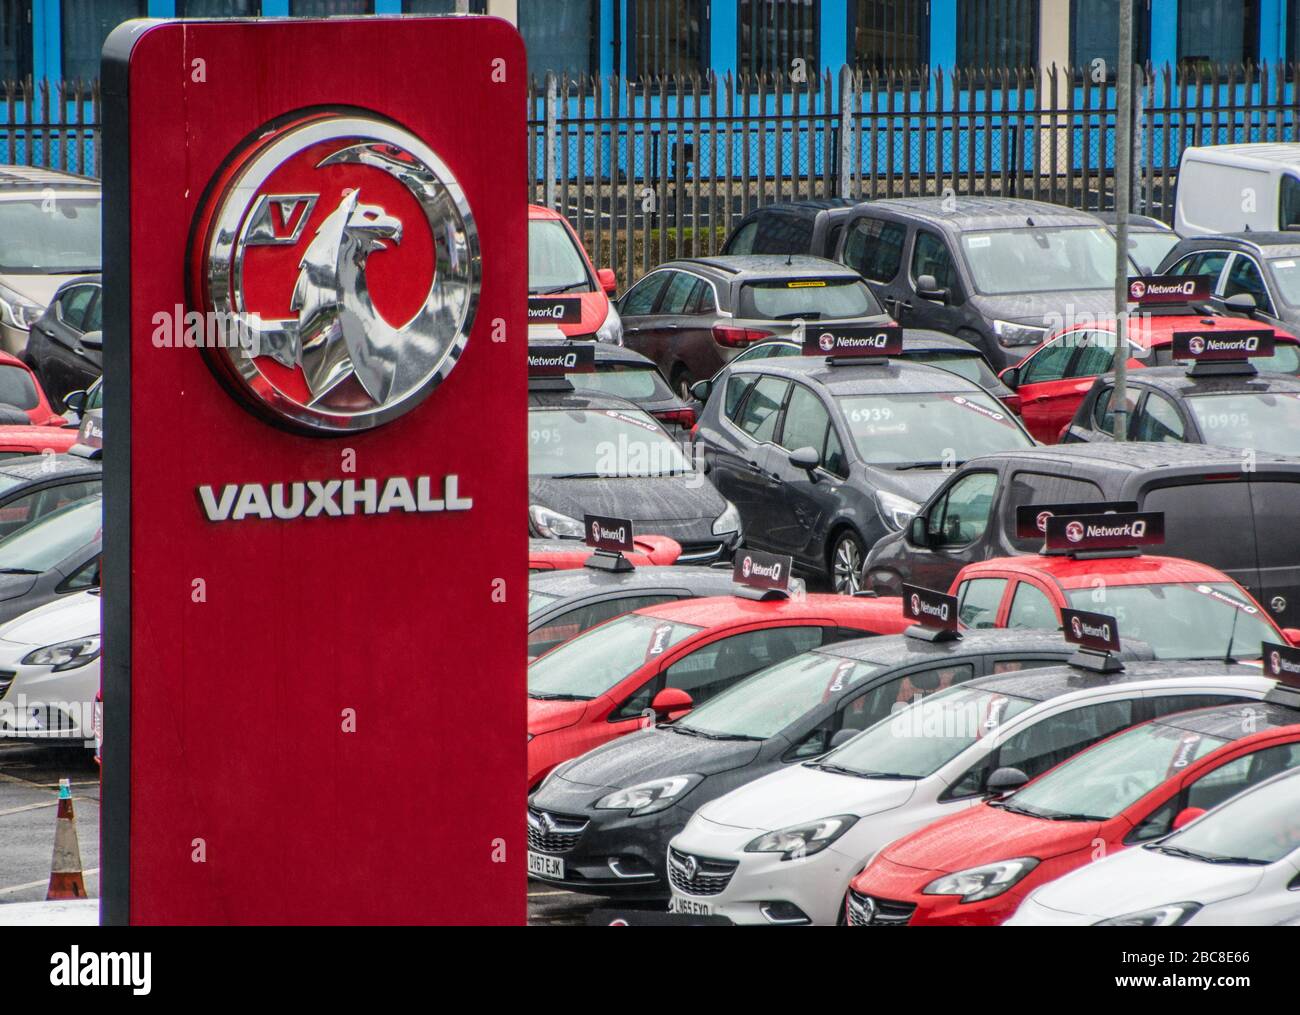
[1000,313,1300,444]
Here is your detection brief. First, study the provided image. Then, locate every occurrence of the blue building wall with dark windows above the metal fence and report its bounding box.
[0,0,1300,79]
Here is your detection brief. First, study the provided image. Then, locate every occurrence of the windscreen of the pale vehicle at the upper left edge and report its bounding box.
[0,196,100,274]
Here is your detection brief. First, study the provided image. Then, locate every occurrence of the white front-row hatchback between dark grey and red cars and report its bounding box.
[668,663,1275,924]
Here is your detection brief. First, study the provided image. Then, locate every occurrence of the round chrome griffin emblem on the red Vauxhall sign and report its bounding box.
[190,112,481,434]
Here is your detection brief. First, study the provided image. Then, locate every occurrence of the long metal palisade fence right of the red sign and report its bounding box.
[529,65,1300,286]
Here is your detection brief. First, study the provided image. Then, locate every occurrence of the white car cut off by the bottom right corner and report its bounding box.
[1005,769,1300,927]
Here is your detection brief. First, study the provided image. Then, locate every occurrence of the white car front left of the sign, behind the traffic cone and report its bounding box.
[0,589,100,749]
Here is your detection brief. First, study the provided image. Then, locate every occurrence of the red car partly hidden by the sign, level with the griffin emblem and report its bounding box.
[528,204,623,346]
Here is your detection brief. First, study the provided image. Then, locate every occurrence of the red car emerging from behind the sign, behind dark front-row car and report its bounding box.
[528,595,910,791]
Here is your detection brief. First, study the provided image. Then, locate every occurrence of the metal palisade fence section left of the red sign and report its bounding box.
[0,78,101,177]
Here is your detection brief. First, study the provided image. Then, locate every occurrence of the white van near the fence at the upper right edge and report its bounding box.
[1174,143,1300,237]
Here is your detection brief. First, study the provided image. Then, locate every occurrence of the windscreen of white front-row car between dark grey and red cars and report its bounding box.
[813,686,1034,778]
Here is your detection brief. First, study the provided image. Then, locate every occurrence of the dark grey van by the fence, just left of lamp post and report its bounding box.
[837,198,1140,370]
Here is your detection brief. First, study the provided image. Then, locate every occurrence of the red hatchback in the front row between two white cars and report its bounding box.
[845,700,1300,927]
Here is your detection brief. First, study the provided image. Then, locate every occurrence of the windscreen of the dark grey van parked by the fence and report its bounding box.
[962,225,1123,296]
